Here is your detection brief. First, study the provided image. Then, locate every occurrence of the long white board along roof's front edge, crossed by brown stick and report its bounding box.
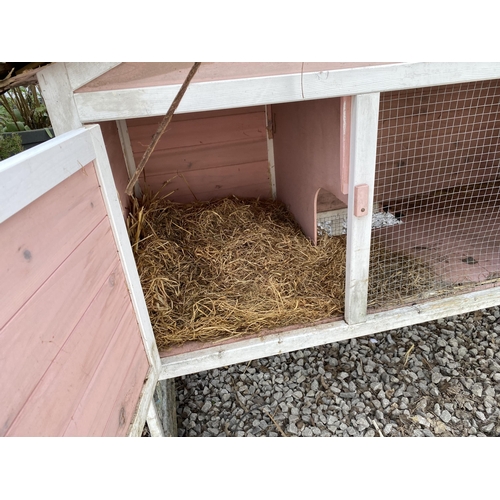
[74,62,500,123]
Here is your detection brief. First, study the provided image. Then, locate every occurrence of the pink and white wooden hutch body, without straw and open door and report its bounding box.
[7,63,500,434]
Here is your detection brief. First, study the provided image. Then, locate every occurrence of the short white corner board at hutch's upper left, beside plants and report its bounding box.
[37,63,82,135]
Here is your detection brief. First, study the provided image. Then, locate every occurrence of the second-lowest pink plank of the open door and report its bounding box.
[64,302,144,436]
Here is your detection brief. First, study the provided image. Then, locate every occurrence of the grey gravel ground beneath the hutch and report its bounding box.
[167,307,500,437]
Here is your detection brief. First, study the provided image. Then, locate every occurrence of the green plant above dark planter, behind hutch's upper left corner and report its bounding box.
[0,84,51,132]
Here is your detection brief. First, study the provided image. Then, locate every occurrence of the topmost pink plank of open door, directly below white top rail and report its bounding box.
[0,164,106,328]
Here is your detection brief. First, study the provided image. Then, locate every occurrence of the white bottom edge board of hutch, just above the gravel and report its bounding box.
[160,287,500,380]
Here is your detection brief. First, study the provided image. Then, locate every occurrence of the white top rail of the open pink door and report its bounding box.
[0,129,95,223]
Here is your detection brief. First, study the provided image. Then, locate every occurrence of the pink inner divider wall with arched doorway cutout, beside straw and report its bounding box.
[272,98,347,243]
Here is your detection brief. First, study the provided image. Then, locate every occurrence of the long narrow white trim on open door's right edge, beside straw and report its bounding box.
[87,125,160,376]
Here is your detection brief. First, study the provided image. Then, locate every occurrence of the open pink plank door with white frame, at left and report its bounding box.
[0,125,159,436]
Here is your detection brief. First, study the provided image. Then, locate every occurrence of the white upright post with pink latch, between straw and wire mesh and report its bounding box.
[345,93,380,324]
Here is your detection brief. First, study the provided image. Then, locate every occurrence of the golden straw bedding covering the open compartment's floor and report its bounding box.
[128,195,438,350]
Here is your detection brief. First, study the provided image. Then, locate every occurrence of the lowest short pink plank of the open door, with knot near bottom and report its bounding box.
[101,338,149,436]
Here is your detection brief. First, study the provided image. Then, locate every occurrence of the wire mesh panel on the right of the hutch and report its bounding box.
[368,80,500,309]
